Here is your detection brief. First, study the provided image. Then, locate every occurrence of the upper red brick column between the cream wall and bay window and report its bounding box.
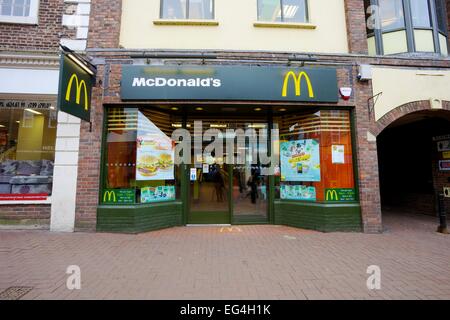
[345,0,368,54]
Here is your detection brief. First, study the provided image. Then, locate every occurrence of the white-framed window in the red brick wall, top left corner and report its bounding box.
[0,0,39,24]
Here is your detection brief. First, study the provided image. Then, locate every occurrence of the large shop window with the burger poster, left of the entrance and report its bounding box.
[101,108,180,205]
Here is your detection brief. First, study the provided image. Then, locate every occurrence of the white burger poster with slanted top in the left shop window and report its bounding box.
[136,112,175,180]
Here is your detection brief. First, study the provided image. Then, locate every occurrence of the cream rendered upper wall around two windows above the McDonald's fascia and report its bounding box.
[120,0,348,53]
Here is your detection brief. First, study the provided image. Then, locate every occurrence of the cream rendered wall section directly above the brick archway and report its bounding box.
[372,67,450,120]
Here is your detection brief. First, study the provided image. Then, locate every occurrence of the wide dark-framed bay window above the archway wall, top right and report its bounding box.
[364,0,448,55]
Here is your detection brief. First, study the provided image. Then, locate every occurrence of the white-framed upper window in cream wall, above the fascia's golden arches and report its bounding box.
[258,0,308,23]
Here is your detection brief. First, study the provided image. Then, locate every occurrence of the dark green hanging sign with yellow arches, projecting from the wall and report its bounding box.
[58,54,94,122]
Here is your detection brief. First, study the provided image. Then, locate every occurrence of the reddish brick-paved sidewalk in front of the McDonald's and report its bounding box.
[0,210,450,299]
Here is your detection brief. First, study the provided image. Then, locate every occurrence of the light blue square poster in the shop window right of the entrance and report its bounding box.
[280,139,320,182]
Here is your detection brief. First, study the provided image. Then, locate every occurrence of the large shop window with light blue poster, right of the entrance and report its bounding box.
[276,110,358,202]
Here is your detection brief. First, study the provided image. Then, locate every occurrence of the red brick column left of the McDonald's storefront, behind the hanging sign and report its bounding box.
[75,0,122,231]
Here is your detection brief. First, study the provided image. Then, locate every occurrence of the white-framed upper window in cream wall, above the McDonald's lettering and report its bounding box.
[161,0,214,19]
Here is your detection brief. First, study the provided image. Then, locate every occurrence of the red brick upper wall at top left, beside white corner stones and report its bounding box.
[0,0,68,52]
